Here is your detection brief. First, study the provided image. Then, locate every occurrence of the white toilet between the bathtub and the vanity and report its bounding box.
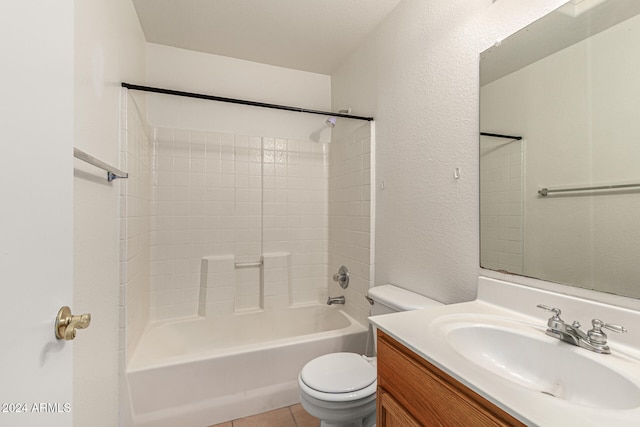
[298,285,442,427]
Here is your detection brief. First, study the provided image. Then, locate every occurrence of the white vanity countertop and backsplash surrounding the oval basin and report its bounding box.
[369,277,640,427]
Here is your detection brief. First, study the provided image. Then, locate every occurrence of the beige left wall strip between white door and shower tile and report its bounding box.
[72,0,144,427]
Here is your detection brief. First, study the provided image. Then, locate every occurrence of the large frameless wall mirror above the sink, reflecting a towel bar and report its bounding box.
[480,0,640,298]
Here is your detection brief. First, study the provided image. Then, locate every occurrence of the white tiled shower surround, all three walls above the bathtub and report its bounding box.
[121,116,371,324]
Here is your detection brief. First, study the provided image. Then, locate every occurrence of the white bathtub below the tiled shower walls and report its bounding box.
[126,305,367,427]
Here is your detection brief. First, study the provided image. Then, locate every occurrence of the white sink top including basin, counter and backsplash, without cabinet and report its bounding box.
[369,277,640,427]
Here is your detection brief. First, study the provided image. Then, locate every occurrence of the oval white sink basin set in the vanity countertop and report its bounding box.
[440,319,640,409]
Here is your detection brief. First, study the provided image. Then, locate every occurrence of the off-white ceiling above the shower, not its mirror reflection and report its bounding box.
[133,0,400,74]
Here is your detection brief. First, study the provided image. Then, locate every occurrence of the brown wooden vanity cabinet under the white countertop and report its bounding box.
[377,330,525,427]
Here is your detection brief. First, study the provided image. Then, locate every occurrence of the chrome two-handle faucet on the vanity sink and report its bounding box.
[537,304,627,354]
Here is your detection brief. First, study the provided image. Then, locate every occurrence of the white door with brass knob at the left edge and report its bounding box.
[0,0,75,427]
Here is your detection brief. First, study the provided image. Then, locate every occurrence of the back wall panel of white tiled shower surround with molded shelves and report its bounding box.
[150,128,329,320]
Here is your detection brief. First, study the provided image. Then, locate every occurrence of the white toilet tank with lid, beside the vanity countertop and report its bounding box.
[368,284,442,316]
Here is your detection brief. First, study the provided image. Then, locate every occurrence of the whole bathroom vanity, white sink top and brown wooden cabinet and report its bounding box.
[370,277,640,427]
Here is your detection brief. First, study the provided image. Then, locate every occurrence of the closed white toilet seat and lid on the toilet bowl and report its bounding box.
[298,353,377,402]
